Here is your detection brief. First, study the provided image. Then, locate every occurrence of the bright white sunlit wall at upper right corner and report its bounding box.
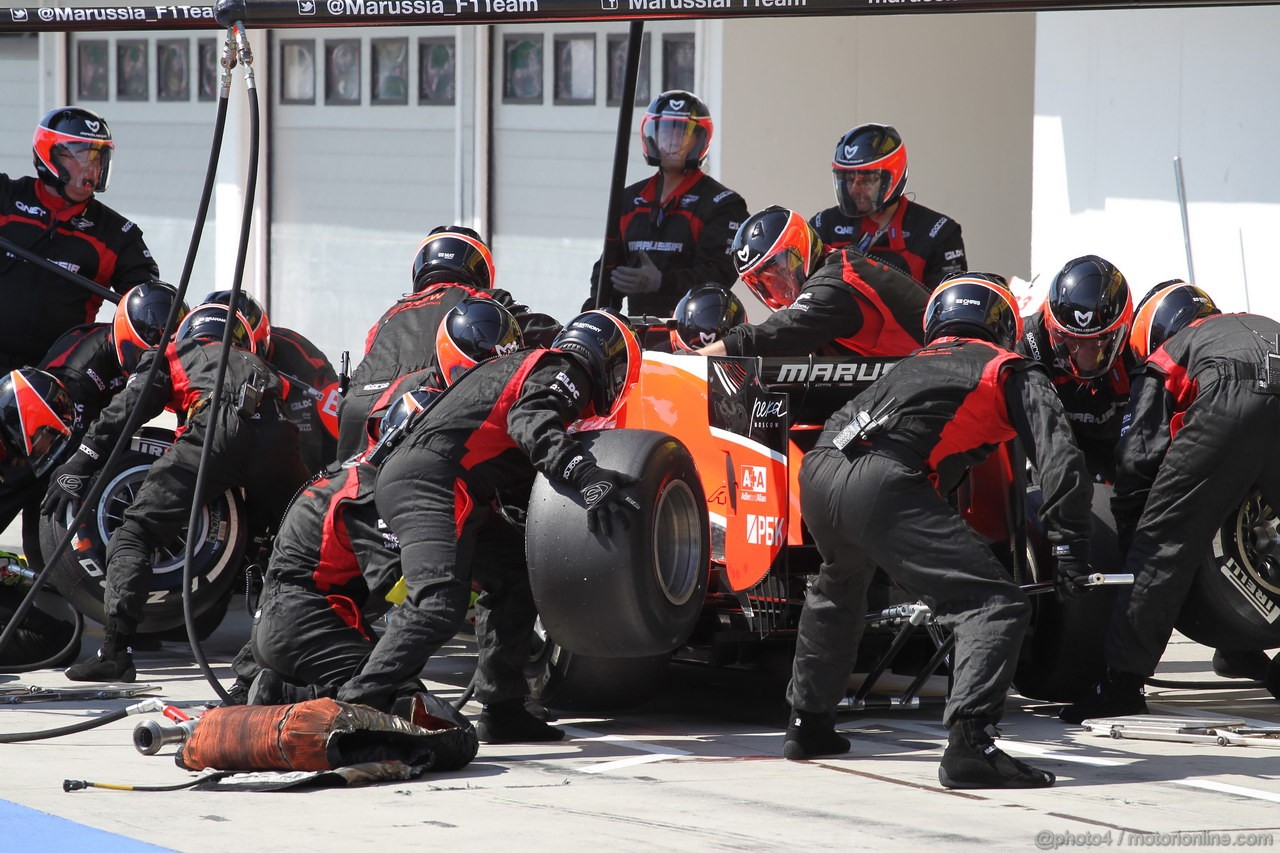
[1032,6,1280,315]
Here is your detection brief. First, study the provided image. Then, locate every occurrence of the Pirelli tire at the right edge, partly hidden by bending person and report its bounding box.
[1178,492,1280,651]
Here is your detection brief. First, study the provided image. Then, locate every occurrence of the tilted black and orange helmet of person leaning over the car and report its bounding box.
[730,205,824,311]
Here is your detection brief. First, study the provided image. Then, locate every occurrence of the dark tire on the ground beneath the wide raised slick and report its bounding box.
[525,622,671,711]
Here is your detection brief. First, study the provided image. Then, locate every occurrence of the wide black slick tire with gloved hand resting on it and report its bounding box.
[526,429,710,658]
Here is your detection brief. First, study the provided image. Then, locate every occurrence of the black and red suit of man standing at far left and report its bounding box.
[0,174,159,371]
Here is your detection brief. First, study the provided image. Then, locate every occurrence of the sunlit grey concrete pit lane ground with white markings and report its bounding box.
[0,607,1280,853]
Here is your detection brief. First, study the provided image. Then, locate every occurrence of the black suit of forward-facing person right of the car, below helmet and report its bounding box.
[1015,311,1134,483]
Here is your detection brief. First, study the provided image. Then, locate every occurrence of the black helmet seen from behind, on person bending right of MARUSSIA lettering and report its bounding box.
[924,273,1023,350]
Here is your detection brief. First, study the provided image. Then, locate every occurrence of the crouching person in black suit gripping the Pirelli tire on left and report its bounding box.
[41,305,307,681]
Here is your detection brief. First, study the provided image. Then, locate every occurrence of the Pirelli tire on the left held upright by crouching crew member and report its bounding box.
[40,427,247,638]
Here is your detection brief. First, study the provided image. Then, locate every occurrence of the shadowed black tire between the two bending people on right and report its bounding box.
[1014,483,1121,702]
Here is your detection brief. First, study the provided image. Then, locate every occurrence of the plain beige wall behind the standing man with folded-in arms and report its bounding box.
[717,14,1036,322]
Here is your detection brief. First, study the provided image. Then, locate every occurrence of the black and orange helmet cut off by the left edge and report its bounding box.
[0,368,76,482]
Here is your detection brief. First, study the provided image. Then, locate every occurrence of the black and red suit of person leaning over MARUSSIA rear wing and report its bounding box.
[723,251,929,356]
